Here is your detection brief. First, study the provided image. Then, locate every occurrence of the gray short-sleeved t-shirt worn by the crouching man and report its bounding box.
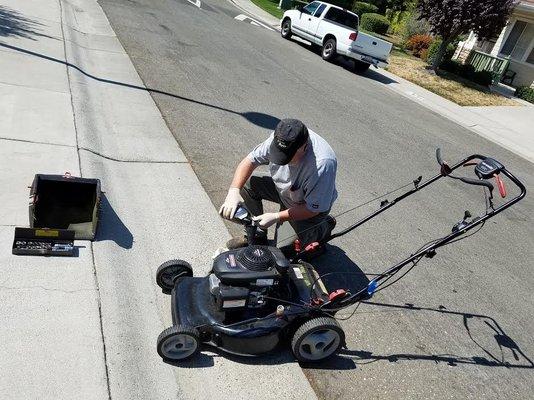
[248,130,337,212]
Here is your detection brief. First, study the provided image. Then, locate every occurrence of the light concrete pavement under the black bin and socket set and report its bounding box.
[0,0,315,399]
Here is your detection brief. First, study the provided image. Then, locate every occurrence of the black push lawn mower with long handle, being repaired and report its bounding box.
[156,149,526,363]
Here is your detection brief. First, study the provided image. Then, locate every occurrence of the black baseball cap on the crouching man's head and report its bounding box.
[269,118,310,165]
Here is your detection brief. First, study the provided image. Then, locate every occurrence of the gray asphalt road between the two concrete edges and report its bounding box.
[100,0,534,398]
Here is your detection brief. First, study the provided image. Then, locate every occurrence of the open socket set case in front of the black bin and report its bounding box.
[11,227,75,257]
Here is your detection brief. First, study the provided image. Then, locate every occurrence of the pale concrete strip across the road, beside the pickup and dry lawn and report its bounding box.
[239,0,534,162]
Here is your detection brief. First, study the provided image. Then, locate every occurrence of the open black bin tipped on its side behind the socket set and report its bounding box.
[29,173,102,240]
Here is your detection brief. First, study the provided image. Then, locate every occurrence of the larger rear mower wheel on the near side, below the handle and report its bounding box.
[291,317,345,363]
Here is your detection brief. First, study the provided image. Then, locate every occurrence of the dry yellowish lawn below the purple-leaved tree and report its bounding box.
[387,50,517,106]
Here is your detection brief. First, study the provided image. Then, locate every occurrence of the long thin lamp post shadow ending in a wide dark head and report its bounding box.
[0,43,280,129]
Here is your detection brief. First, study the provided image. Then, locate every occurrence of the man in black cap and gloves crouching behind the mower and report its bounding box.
[219,119,337,252]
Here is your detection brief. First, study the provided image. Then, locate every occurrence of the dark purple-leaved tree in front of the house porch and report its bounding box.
[417,0,516,70]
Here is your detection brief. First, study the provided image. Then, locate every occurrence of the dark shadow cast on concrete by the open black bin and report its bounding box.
[96,195,133,249]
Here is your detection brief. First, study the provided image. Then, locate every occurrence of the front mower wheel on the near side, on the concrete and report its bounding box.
[157,325,200,362]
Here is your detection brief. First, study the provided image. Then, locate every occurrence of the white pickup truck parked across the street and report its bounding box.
[280,1,393,72]
